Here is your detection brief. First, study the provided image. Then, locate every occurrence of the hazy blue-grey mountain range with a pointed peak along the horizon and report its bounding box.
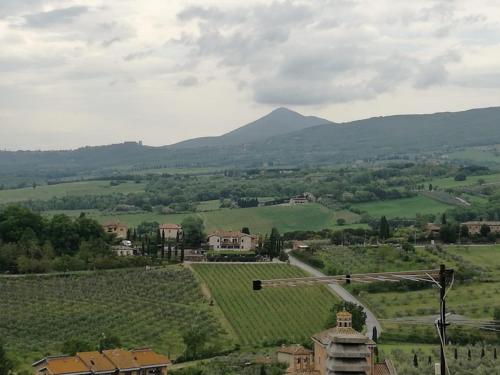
[0,107,500,178]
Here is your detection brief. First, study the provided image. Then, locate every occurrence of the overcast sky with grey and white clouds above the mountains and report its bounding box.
[0,0,500,150]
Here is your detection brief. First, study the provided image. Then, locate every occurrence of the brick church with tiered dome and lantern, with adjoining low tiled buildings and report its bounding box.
[278,311,397,375]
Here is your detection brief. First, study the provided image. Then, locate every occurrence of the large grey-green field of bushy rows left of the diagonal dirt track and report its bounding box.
[0,267,226,363]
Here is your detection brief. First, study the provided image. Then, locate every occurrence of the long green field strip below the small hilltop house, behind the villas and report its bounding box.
[47,201,358,233]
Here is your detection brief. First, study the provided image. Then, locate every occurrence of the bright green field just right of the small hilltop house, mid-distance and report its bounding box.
[351,195,453,219]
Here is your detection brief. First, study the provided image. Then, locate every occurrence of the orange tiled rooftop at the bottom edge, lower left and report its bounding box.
[33,349,170,375]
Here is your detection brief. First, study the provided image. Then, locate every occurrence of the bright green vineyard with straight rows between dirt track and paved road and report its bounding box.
[193,264,337,347]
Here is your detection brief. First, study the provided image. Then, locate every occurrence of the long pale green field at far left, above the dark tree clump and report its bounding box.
[0,181,146,204]
